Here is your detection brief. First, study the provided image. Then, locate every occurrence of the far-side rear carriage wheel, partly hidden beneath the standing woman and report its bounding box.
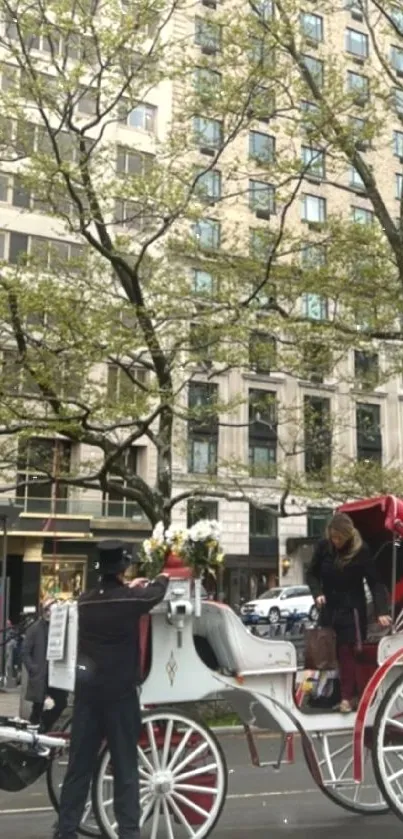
[302,730,389,815]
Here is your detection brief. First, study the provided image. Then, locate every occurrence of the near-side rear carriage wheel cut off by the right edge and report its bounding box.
[372,675,403,820]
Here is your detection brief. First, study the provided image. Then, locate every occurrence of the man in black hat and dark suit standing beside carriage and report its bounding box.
[55,542,169,839]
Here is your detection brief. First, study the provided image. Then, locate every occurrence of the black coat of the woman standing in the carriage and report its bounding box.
[307,539,388,643]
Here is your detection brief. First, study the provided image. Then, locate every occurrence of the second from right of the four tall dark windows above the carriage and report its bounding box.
[304,396,331,476]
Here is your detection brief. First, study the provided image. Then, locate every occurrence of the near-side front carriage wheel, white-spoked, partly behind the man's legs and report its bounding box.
[92,708,227,839]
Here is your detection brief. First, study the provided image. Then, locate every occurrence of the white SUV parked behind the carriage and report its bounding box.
[241,586,318,624]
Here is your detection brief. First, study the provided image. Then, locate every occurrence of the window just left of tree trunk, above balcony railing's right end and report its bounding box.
[102,446,141,519]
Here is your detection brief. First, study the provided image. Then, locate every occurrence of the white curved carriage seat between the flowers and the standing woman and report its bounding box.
[194,601,297,676]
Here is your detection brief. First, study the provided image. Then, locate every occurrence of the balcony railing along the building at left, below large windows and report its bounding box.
[12,496,148,523]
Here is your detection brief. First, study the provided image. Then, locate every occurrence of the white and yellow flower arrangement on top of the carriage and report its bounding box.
[140,519,224,579]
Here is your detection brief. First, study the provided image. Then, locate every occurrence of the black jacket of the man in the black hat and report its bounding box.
[75,576,168,700]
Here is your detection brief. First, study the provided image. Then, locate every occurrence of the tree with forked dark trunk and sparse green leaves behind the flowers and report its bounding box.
[0,0,403,523]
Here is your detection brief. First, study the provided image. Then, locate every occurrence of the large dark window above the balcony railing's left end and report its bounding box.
[16,437,71,515]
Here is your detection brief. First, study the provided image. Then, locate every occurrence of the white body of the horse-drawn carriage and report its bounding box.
[45,578,403,734]
